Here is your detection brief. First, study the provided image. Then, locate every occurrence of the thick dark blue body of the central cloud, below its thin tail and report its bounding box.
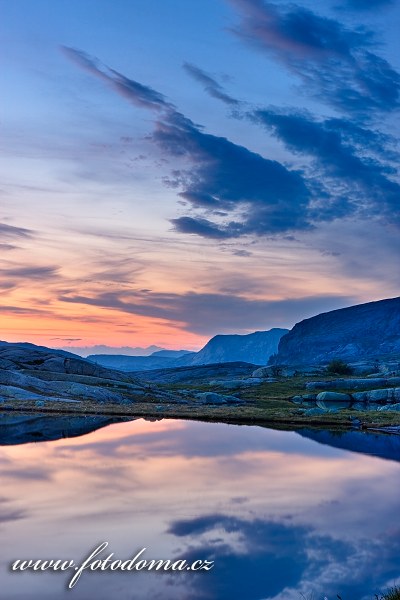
[153,112,311,238]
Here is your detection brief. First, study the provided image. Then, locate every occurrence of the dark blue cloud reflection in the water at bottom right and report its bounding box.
[168,514,400,600]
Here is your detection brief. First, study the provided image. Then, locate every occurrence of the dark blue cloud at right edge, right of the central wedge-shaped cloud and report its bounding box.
[251,109,400,223]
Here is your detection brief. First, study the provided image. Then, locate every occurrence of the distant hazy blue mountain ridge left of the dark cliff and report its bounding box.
[88,329,288,371]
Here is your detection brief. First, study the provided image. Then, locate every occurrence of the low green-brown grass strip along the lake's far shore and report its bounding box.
[0,376,400,431]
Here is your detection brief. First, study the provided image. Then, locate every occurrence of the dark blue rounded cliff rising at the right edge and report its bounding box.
[276,298,400,365]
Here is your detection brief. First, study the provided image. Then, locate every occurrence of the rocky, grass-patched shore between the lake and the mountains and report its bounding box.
[0,342,400,439]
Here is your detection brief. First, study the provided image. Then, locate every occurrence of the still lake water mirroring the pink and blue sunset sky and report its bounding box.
[0,417,400,600]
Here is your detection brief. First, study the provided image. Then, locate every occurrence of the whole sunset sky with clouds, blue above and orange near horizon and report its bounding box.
[0,0,400,350]
